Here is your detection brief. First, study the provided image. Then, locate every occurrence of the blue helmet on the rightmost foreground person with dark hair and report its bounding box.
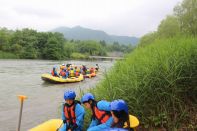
[110,99,128,113]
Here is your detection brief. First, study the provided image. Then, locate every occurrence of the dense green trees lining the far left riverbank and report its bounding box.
[0,28,133,60]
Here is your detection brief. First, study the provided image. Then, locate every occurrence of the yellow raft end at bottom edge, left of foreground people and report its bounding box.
[28,119,62,131]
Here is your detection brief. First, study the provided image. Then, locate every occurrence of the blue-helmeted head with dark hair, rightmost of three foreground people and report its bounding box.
[110,100,129,126]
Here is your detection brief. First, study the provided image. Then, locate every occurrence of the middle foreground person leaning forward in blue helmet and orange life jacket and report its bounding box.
[81,93,113,131]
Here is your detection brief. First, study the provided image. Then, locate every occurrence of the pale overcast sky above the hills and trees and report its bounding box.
[0,0,182,37]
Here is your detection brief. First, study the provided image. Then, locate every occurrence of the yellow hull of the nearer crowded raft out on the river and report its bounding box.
[41,73,84,83]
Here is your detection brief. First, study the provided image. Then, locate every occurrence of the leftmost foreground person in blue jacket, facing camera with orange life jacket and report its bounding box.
[59,91,85,131]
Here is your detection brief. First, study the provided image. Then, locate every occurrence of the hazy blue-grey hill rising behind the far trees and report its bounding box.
[51,26,139,45]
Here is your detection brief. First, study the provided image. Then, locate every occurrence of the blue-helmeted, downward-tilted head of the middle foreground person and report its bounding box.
[81,93,95,109]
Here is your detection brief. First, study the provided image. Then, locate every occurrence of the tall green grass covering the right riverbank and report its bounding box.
[94,37,197,130]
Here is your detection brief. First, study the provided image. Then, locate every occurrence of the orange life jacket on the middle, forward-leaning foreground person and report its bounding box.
[92,103,111,124]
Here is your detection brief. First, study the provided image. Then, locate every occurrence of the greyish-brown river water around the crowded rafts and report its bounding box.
[0,60,113,131]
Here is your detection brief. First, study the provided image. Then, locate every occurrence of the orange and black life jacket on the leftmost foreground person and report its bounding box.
[64,100,81,125]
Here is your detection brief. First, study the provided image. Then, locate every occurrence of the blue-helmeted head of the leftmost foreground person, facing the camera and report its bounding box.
[64,91,76,105]
